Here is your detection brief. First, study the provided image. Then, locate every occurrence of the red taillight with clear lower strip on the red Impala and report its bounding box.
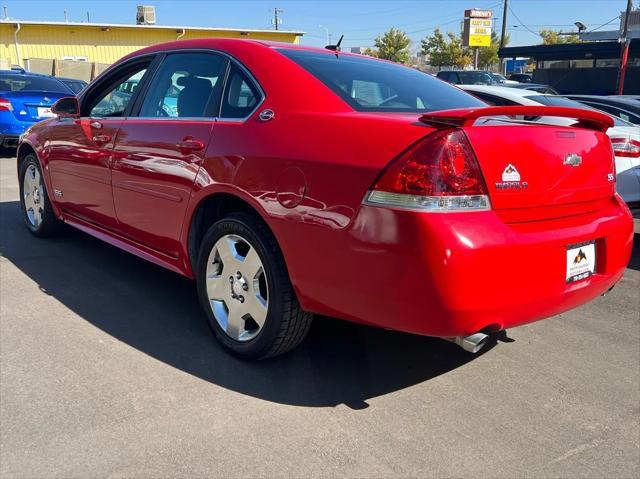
[365,130,491,211]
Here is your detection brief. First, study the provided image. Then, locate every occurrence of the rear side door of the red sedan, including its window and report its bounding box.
[112,51,229,257]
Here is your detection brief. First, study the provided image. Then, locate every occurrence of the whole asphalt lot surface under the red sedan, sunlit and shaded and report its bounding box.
[0,158,640,478]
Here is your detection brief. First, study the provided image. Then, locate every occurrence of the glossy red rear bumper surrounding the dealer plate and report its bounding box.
[287,197,633,336]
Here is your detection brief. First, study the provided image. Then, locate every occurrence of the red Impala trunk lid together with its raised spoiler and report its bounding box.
[421,107,615,222]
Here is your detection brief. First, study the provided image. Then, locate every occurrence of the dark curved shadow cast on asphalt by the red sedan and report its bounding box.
[0,202,491,409]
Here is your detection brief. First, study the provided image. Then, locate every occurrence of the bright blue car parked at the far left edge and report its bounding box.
[0,70,74,148]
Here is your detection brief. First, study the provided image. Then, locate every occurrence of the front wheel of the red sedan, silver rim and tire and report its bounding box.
[18,153,64,238]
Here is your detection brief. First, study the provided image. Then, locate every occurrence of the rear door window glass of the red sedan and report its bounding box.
[139,53,228,118]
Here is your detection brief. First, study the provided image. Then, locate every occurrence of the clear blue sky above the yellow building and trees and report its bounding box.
[1,0,628,48]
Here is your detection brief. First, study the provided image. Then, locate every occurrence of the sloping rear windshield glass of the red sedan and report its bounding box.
[280,49,486,113]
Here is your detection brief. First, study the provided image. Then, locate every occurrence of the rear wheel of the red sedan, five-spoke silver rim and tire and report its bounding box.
[197,213,313,359]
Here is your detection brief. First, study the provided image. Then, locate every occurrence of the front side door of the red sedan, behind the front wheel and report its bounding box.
[47,58,152,230]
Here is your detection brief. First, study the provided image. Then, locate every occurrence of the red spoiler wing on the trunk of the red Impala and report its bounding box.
[420,105,613,133]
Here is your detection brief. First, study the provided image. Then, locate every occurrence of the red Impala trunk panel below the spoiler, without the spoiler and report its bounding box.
[465,125,615,209]
